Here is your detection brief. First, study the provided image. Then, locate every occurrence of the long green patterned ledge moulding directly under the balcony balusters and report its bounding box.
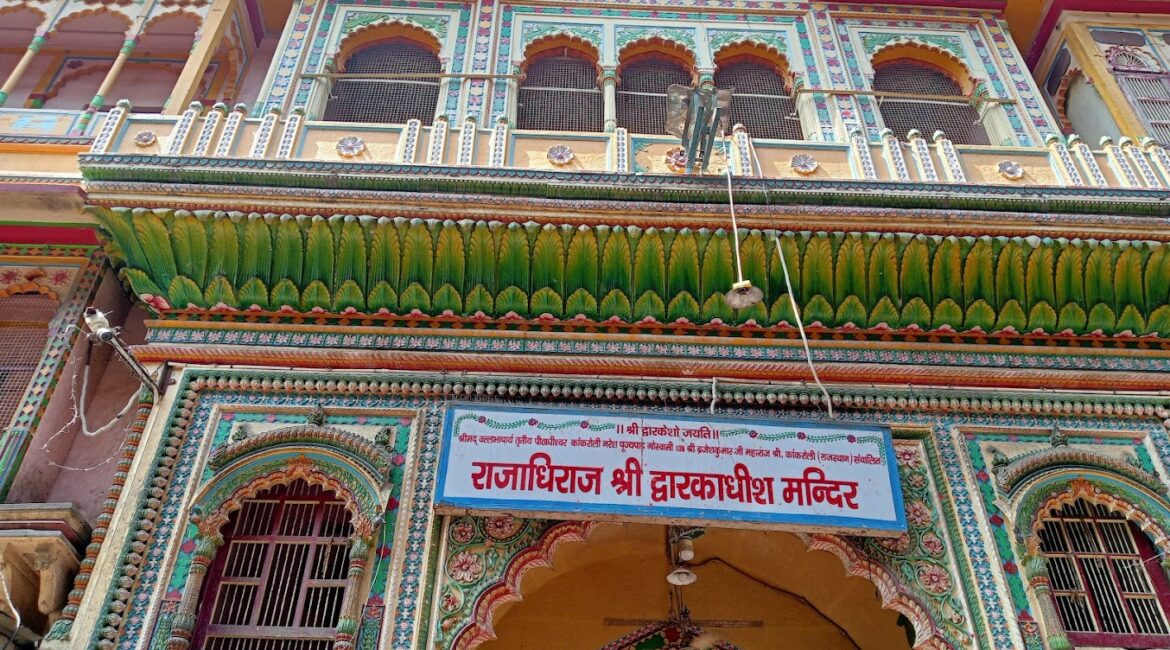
[78,153,1170,216]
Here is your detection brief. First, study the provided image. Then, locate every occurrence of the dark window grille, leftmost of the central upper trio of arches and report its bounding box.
[516,56,605,132]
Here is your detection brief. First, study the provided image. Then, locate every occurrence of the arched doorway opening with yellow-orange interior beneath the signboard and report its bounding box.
[480,524,914,650]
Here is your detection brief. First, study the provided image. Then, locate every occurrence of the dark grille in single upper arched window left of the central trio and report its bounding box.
[325,41,442,124]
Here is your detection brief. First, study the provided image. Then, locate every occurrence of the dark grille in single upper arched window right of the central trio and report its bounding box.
[874,62,991,145]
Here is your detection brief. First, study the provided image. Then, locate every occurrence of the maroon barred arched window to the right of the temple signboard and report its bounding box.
[1040,499,1170,648]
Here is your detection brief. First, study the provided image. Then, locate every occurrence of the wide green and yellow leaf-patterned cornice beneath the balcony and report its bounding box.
[92,208,1170,338]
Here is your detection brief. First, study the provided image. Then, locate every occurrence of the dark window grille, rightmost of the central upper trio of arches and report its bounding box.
[715,61,804,140]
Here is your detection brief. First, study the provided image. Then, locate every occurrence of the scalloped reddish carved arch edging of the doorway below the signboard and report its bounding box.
[450,521,952,650]
